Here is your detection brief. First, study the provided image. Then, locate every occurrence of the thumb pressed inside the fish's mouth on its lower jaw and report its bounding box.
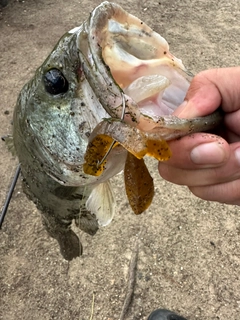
[173,67,240,118]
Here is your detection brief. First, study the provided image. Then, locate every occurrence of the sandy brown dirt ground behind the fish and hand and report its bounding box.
[0,0,240,320]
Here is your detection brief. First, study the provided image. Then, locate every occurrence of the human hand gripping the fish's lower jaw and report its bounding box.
[159,67,240,205]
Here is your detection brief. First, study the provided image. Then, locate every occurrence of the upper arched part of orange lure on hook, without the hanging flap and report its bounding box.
[83,121,172,176]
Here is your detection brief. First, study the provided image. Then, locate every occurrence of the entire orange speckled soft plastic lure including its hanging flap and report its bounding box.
[83,121,171,214]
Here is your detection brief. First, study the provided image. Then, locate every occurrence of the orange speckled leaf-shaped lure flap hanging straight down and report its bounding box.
[124,152,154,214]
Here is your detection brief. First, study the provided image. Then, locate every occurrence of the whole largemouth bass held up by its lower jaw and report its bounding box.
[13,2,220,260]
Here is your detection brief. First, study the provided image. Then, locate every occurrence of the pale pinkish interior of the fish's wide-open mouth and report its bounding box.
[85,2,190,122]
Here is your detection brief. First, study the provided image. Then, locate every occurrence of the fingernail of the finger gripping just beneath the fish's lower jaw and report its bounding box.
[190,142,226,165]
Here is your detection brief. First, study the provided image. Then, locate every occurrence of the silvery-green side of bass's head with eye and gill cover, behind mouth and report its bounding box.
[13,26,126,186]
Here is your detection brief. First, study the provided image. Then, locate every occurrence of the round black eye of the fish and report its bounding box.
[43,68,68,95]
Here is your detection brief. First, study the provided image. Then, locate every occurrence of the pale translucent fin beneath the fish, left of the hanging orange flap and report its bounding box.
[86,181,116,226]
